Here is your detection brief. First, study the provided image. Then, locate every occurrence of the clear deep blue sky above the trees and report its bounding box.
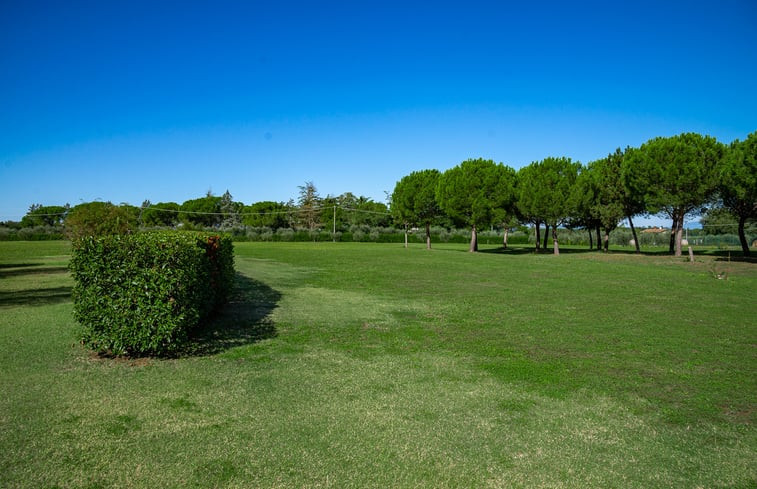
[0,0,757,220]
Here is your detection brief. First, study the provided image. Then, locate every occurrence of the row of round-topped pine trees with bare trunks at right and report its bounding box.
[391,132,757,256]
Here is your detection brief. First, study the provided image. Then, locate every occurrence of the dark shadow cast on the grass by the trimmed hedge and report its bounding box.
[179,273,281,356]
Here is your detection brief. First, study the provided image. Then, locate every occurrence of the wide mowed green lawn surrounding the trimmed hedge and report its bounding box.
[0,243,757,488]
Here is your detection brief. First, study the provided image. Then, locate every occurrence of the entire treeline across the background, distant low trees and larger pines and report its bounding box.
[7,133,757,254]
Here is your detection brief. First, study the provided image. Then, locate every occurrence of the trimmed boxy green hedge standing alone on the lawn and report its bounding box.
[70,232,234,355]
